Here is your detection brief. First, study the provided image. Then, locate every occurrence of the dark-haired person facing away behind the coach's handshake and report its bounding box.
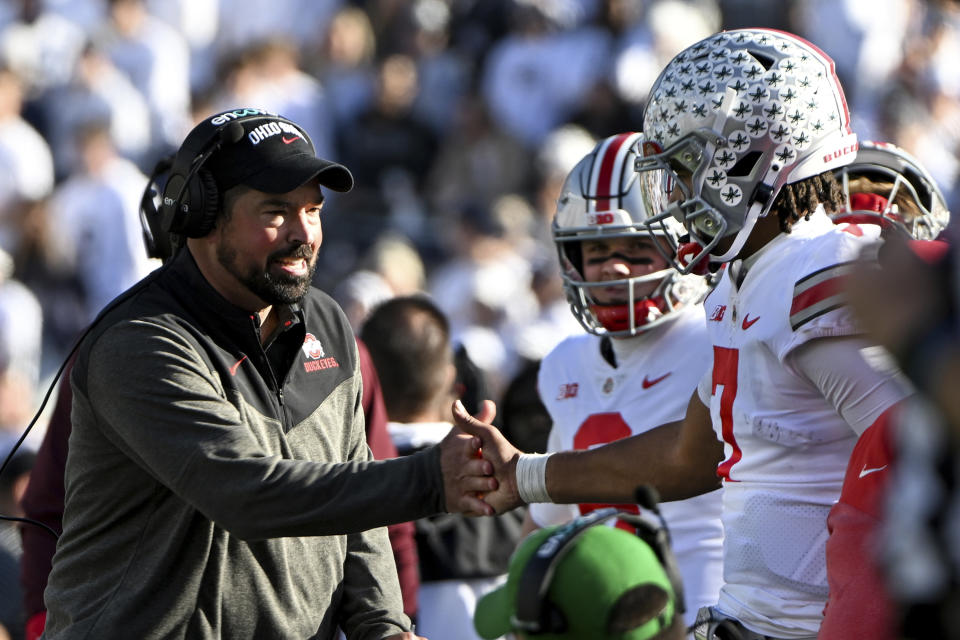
[361,295,522,640]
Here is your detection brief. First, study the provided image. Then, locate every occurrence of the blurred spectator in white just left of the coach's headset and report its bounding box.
[48,123,154,321]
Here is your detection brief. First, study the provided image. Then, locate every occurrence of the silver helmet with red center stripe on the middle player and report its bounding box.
[552,133,707,337]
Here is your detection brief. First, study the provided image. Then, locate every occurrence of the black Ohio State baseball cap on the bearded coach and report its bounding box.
[197,108,353,193]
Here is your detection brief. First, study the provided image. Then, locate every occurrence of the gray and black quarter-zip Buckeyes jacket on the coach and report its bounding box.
[38,250,443,640]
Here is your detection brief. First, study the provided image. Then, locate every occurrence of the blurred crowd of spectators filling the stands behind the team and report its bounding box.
[0,0,960,454]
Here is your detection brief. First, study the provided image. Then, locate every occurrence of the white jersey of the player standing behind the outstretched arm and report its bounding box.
[530,305,723,624]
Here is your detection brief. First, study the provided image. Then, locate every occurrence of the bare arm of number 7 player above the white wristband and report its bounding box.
[547,422,720,503]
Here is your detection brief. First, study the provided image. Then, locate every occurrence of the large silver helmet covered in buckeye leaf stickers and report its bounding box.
[637,29,857,273]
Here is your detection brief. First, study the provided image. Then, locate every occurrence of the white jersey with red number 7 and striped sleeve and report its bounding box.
[699,209,879,638]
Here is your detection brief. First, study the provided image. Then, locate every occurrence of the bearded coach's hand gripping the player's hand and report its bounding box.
[440,403,497,516]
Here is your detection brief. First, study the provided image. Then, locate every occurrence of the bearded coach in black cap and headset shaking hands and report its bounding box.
[44,109,492,640]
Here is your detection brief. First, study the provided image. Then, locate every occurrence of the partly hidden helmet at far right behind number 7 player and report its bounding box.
[831,141,950,240]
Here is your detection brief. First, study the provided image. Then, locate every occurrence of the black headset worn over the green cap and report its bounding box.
[510,485,686,635]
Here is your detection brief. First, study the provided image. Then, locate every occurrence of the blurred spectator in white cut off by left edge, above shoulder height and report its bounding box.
[0,68,53,252]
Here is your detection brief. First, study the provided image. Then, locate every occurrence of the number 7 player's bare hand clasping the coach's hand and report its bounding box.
[453,400,523,513]
